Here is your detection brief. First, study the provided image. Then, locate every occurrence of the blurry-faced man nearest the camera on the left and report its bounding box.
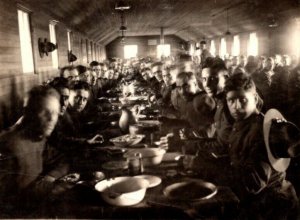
[0,86,67,217]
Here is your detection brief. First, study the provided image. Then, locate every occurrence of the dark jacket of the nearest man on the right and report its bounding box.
[229,114,298,219]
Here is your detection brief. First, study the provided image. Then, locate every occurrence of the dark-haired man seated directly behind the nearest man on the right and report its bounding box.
[163,61,233,179]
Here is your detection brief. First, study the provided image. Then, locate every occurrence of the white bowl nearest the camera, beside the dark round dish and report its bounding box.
[95,176,149,206]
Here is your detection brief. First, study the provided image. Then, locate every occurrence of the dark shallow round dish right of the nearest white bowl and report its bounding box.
[163,179,218,201]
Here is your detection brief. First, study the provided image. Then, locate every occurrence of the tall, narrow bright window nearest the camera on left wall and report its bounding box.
[18,9,34,73]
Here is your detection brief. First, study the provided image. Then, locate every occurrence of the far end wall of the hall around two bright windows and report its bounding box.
[106,35,187,58]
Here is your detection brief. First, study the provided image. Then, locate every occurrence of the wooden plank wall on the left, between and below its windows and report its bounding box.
[0,0,105,130]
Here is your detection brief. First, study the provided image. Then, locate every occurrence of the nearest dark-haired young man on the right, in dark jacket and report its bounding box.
[225,73,297,219]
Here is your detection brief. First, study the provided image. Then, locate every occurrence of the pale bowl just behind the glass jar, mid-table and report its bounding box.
[124,148,166,166]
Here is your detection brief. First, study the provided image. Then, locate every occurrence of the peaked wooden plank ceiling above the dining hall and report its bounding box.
[24,0,300,45]
